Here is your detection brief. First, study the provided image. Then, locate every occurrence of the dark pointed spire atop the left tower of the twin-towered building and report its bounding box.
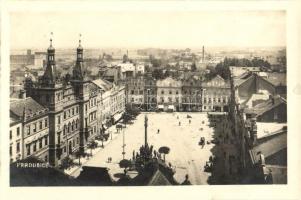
[43,32,56,84]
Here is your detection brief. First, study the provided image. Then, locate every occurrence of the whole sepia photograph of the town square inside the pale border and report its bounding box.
[9,10,289,186]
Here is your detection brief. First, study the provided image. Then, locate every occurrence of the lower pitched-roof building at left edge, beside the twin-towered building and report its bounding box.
[10,97,49,162]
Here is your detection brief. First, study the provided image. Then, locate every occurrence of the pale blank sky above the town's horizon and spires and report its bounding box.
[10,10,286,49]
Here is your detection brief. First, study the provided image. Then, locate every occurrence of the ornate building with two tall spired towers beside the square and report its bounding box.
[25,40,92,166]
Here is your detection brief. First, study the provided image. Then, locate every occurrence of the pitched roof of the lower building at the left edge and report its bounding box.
[10,97,47,117]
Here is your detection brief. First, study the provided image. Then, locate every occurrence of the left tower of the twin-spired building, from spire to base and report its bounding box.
[25,37,64,166]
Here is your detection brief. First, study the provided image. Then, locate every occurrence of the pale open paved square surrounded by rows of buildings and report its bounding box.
[72,113,214,185]
